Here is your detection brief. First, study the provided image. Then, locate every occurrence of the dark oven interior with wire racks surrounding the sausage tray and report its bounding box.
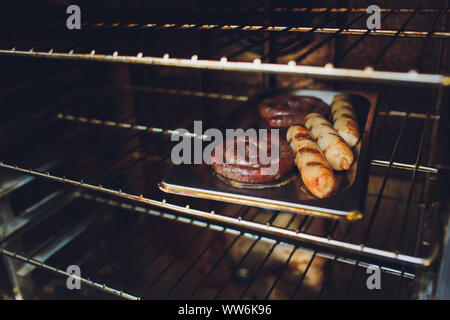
[0,0,450,299]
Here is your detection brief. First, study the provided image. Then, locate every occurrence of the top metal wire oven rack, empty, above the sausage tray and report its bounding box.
[0,8,450,86]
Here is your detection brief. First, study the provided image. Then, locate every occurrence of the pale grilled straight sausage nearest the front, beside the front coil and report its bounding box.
[287,126,336,198]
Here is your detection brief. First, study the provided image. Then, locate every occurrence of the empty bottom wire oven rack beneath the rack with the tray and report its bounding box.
[0,194,416,300]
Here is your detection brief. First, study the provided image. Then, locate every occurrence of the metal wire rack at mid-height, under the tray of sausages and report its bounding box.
[0,82,437,266]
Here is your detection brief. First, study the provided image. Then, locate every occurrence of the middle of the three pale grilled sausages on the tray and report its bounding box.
[305,113,354,171]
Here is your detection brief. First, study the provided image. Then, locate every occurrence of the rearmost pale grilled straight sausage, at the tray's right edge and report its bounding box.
[331,95,359,147]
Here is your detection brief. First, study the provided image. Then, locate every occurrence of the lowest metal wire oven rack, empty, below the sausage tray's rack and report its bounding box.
[0,194,414,299]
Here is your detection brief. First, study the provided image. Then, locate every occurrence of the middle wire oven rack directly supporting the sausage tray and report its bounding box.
[0,83,441,267]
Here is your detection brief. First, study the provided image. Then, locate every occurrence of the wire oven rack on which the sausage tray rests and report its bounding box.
[0,81,439,266]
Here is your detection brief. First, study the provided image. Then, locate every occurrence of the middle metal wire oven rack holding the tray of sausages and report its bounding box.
[0,79,438,266]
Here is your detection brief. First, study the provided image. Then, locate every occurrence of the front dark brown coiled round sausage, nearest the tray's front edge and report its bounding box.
[211,135,295,184]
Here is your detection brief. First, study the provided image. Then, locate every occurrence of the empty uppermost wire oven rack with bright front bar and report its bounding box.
[0,8,450,87]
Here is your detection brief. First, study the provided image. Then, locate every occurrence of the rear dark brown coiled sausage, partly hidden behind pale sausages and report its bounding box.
[258,95,330,128]
